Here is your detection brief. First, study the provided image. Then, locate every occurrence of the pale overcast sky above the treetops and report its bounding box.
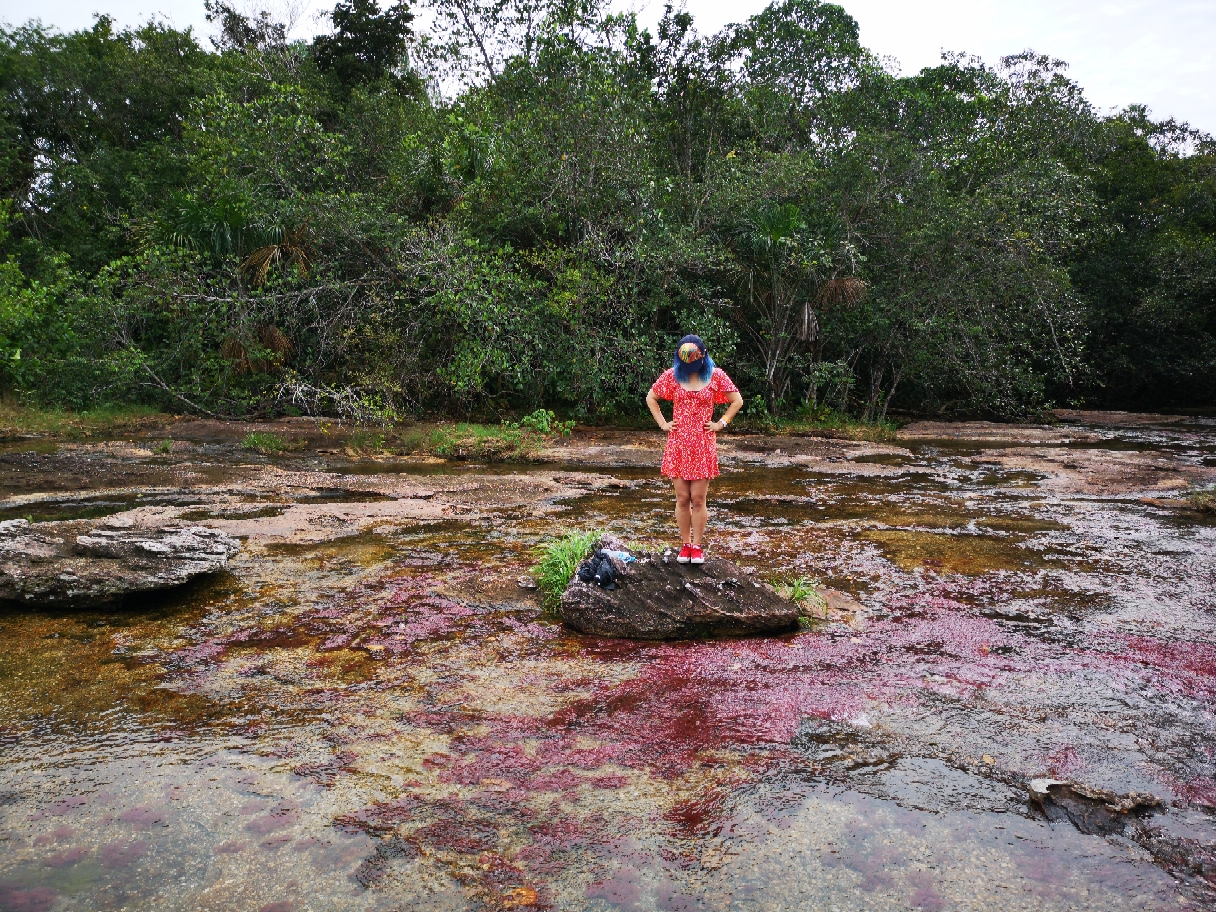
[9,0,1216,133]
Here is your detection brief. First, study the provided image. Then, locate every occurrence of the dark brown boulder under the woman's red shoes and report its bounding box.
[558,545,799,640]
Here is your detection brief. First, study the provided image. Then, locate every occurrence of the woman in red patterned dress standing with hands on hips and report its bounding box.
[646,336,743,564]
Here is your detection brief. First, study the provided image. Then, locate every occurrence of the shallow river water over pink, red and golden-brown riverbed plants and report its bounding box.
[0,426,1216,912]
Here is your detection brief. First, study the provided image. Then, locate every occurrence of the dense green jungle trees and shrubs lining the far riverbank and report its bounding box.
[0,0,1216,421]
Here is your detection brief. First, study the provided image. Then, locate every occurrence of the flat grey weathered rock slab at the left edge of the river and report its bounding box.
[0,516,241,607]
